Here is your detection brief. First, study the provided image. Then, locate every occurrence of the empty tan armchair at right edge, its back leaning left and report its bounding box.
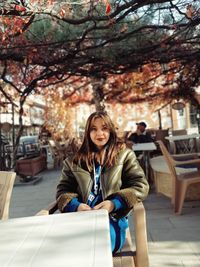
[157,141,200,214]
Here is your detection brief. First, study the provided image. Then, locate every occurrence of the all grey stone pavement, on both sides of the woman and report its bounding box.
[10,166,200,267]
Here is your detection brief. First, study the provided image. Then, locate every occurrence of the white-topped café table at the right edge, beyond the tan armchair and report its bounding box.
[165,134,200,154]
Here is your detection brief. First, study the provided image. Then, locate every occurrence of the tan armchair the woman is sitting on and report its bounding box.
[36,202,149,267]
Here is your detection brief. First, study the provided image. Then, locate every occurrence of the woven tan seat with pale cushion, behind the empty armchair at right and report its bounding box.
[150,156,200,201]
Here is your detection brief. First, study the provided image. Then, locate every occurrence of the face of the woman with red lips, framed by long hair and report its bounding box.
[90,118,110,149]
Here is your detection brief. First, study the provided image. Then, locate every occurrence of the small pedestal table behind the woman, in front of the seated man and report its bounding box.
[132,142,157,181]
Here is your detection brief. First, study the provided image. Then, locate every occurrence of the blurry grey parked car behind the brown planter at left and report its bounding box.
[17,135,40,158]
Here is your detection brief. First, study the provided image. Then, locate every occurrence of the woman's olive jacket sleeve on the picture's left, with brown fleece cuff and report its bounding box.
[56,160,79,212]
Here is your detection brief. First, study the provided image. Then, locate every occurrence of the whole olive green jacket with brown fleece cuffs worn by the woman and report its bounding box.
[56,148,149,218]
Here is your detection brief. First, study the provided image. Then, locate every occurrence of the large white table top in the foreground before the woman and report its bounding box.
[0,210,113,267]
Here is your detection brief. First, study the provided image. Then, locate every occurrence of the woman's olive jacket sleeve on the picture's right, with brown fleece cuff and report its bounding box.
[107,149,149,217]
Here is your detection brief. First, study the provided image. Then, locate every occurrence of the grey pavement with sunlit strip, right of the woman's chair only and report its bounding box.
[144,193,200,267]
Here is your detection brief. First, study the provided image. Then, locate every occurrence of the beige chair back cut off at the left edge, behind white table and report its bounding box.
[0,171,16,220]
